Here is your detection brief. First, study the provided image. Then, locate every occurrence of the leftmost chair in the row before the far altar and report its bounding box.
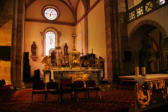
[32,81,47,104]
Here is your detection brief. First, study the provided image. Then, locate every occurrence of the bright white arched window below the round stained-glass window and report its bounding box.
[45,31,56,56]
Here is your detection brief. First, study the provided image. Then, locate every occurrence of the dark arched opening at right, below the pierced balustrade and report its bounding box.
[128,21,167,73]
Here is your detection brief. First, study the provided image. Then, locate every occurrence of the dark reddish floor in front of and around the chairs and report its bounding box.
[0,85,136,112]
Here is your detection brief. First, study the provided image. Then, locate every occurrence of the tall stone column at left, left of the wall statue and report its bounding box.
[11,0,25,88]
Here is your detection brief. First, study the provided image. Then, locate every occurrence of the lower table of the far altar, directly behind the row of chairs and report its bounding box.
[43,67,103,83]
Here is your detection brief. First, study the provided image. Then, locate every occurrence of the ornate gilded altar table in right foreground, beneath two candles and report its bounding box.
[119,74,168,108]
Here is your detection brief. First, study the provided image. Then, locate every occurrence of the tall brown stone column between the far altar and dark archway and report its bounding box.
[104,0,121,81]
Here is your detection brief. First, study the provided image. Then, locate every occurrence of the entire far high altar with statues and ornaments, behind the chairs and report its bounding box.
[42,43,104,83]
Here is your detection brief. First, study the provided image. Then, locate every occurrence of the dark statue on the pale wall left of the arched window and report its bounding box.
[31,41,37,61]
